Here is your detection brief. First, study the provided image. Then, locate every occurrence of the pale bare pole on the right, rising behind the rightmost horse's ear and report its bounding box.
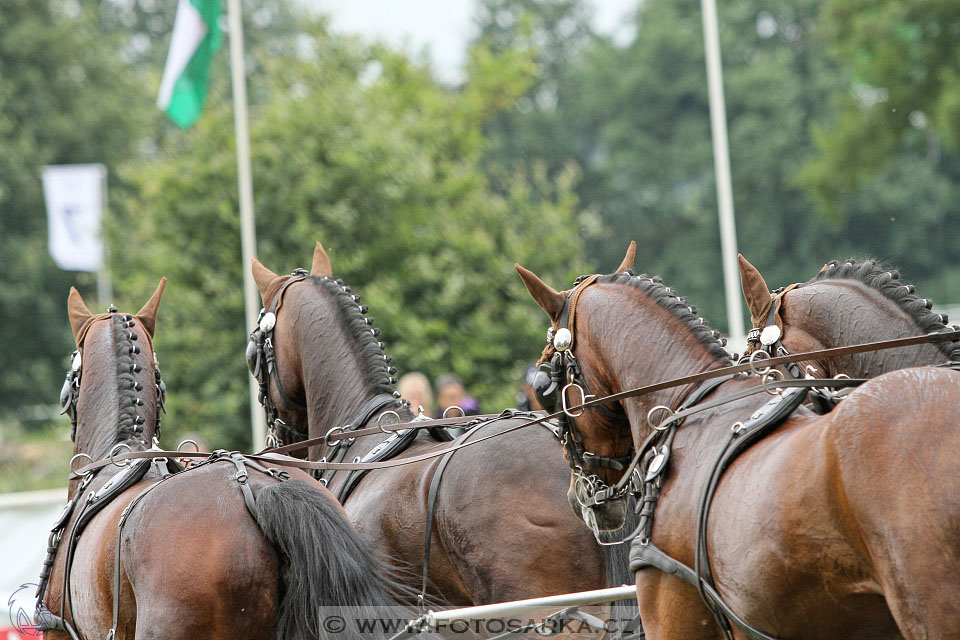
[700,0,746,351]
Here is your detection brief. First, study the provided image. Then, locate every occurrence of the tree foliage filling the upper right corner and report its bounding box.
[801,0,960,209]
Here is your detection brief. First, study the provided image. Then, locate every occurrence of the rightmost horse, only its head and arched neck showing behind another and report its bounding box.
[739,255,960,378]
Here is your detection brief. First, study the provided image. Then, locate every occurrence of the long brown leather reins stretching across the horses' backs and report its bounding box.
[71,329,960,478]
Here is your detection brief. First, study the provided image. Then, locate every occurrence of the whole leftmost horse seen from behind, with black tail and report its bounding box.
[36,279,416,640]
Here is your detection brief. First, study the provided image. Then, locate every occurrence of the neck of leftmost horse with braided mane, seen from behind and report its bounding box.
[74,315,158,490]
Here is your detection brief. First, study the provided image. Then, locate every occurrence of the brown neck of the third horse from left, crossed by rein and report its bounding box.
[578,285,729,441]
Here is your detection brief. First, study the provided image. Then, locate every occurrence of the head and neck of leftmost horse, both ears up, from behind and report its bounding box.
[60,278,166,496]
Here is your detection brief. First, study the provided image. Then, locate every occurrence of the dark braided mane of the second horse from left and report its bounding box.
[307,276,396,394]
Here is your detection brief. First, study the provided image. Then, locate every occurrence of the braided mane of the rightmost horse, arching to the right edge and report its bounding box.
[804,259,960,357]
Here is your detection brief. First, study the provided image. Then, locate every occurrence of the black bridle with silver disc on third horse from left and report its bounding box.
[533,274,638,528]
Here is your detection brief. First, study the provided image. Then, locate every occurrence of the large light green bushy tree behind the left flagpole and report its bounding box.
[110,16,592,447]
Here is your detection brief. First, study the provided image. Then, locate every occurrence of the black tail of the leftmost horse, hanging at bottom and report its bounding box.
[254,480,413,640]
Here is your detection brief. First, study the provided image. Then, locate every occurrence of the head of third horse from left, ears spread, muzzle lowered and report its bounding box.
[517,242,700,530]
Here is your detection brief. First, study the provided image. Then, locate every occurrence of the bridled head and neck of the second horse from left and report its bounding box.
[247,242,396,455]
